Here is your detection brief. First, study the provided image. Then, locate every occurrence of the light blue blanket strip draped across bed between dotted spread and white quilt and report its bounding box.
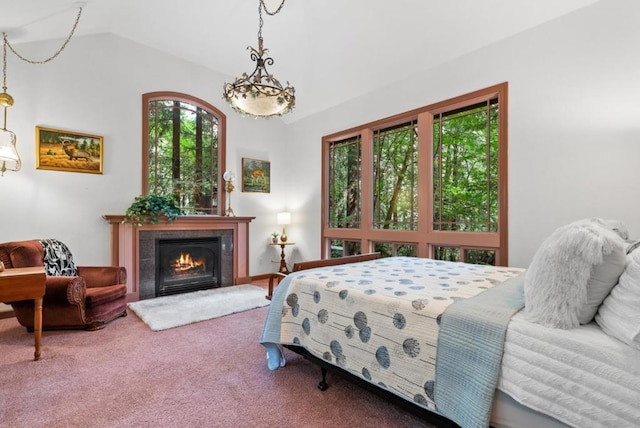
[434,274,524,428]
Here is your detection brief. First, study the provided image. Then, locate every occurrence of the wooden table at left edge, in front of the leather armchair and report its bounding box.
[0,266,45,361]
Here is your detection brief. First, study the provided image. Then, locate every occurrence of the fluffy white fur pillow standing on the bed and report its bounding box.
[524,219,625,329]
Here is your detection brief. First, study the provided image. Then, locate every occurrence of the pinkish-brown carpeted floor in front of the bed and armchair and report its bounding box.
[0,308,436,428]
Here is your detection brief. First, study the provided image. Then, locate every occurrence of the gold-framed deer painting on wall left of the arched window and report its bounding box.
[36,126,103,174]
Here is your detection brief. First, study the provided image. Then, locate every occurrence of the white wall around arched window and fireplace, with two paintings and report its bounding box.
[0,34,287,273]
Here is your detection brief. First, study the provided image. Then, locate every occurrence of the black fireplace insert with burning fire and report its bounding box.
[155,237,222,297]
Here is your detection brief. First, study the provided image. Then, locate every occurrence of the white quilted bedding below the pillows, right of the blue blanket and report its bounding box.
[498,314,640,428]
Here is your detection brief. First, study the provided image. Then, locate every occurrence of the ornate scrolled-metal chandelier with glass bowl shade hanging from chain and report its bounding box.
[224,0,296,117]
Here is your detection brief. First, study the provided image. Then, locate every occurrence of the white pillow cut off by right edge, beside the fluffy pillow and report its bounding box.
[596,251,640,349]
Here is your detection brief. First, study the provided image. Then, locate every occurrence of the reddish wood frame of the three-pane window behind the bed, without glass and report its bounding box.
[321,82,509,266]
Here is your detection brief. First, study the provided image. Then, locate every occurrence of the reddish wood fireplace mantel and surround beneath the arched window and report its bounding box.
[102,214,255,301]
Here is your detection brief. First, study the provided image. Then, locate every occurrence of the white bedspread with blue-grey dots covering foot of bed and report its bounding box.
[262,257,522,410]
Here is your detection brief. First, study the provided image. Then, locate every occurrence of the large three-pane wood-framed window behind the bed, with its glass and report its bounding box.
[322,83,508,265]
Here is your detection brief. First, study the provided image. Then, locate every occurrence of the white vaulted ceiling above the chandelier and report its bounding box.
[0,0,599,122]
